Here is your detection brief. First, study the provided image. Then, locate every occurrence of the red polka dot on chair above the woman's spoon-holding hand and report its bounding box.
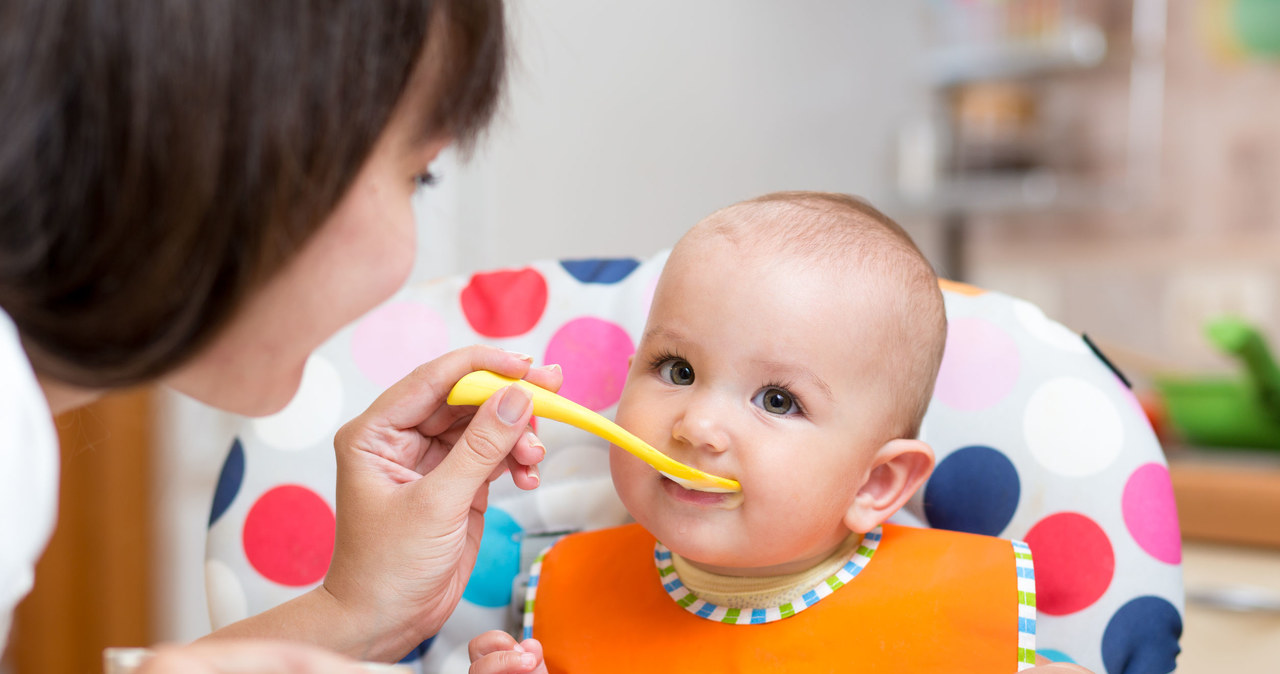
[461,267,547,338]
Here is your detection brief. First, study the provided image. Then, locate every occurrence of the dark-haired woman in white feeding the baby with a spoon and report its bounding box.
[0,0,561,671]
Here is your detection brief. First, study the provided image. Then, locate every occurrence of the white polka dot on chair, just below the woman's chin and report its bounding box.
[252,356,343,449]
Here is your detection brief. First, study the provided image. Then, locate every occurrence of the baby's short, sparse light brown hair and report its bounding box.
[687,192,947,437]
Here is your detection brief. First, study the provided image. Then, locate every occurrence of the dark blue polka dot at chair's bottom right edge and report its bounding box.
[1102,596,1183,674]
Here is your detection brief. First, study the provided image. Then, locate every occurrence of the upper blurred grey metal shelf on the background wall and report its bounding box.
[927,24,1107,87]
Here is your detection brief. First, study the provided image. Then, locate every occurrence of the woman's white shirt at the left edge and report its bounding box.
[0,310,58,650]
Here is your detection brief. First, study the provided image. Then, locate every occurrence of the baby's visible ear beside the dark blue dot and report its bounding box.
[845,439,933,533]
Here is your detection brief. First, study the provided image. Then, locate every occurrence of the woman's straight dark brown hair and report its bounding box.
[0,0,506,388]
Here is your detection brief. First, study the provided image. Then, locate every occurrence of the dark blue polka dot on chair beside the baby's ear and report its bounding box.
[924,445,1021,536]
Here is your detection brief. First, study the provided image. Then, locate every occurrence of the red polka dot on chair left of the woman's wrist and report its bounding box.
[244,485,334,586]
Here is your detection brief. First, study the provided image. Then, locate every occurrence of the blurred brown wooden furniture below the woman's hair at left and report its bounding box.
[5,391,151,674]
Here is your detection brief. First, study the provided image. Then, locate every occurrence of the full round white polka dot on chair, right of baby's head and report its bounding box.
[1023,377,1124,477]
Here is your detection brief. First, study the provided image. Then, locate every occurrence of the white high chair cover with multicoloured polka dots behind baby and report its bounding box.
[206,253,1183,674]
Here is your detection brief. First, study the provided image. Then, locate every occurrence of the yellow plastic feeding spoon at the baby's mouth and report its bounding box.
[448,370,742,494]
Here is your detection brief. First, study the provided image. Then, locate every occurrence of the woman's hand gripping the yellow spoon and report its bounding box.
[324,347,562,659]
